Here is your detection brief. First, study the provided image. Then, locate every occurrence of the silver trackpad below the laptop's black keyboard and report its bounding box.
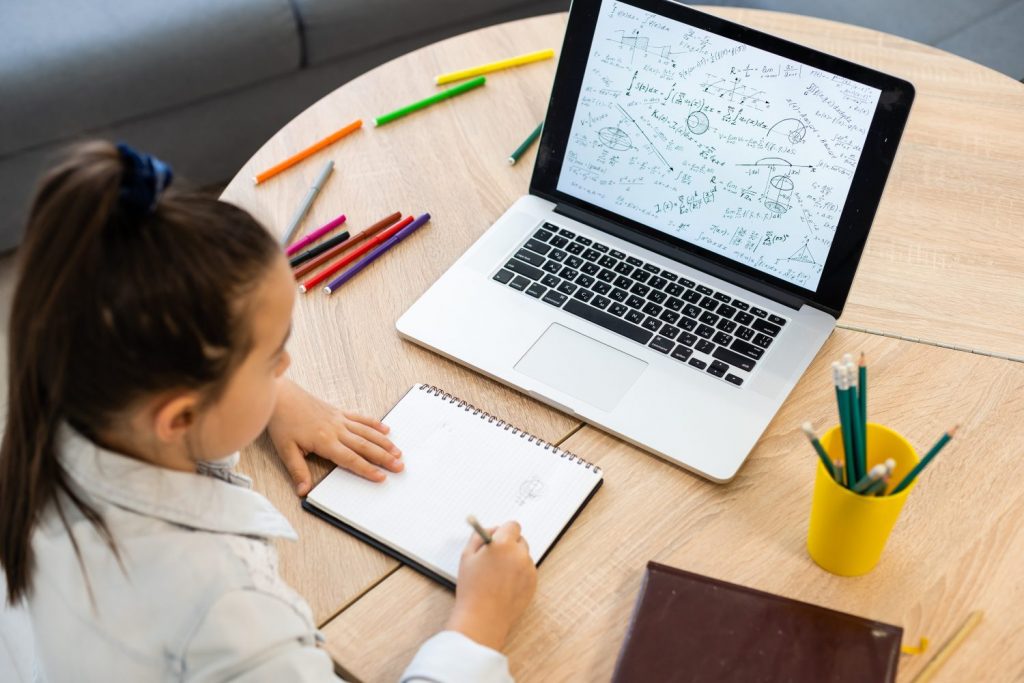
[515,324,647,412]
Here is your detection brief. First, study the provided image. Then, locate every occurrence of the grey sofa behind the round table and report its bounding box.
[0,0,1024,251]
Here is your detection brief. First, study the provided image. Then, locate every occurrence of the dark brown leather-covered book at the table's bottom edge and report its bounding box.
[612,562,903,683]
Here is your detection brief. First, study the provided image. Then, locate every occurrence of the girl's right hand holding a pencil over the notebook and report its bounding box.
[446,522,537,650]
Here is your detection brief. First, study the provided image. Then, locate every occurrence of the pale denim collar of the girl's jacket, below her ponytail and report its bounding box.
[58,425,298,541]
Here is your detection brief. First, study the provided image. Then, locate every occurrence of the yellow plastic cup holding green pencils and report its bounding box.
[807,422,918,577]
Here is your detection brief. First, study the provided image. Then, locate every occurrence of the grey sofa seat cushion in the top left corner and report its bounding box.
[0,0,299,156]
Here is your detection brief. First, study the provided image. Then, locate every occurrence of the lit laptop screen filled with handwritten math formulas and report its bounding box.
[557,0,883,292]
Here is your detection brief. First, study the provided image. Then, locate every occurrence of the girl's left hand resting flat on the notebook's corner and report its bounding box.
[266,379,403,496]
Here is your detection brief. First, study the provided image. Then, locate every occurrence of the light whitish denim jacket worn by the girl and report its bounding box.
[28,427,511,683]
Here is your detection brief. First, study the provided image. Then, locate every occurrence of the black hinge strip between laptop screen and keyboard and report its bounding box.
[555,204,815,317]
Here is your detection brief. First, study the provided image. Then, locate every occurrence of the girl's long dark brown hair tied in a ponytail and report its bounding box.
[0,142,281,604]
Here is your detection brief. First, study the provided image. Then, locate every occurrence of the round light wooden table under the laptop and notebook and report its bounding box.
[223,8,1024,681]
